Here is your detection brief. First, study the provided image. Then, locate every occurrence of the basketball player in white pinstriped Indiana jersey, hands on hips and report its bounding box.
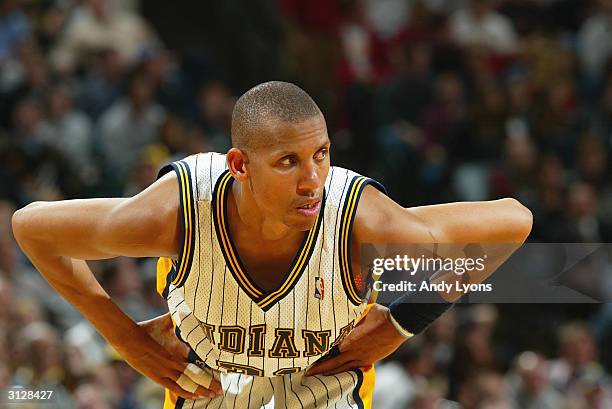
[13,82,531,408]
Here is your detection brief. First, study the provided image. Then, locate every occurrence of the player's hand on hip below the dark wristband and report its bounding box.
[306,304,406,375]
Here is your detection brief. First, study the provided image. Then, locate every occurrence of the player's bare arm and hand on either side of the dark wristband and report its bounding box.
[308,186,532,375]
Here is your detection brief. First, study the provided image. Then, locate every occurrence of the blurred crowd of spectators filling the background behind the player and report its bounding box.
[0,0,612,409]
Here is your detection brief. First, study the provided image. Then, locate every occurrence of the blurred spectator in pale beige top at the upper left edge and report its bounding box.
[51,0,157,72]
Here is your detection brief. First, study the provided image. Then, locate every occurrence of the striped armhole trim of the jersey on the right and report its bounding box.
[338,176,387,305]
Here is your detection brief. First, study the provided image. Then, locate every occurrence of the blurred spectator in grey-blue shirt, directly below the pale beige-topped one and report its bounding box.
[98,74,165,184]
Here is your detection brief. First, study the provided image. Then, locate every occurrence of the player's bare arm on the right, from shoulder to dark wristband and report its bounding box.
[353,186,532,301]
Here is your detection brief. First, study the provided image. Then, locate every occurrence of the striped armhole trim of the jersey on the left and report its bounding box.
[157,160,196,286]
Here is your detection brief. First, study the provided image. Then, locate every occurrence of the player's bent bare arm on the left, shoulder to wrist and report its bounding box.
[12,173,220,398]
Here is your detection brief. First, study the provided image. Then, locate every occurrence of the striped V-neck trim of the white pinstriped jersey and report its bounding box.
[211,169,326,311]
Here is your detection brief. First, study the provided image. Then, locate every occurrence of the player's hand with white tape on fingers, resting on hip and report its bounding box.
[113,316,221,399]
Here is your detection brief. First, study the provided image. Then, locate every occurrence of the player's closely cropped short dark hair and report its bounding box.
[232,81,321,149]
